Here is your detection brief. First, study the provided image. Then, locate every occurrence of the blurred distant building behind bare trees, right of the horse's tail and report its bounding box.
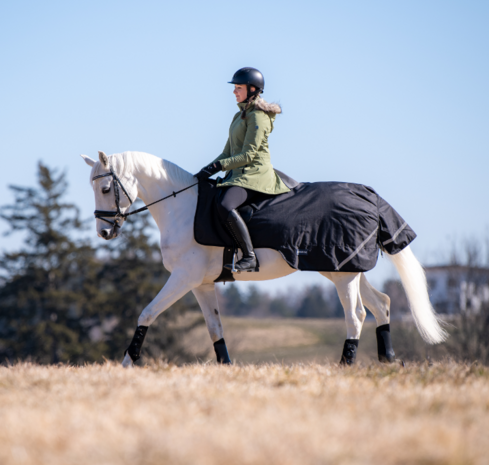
[425,265,489,315]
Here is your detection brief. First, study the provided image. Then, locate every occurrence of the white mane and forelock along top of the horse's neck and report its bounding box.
[90,152,196,188]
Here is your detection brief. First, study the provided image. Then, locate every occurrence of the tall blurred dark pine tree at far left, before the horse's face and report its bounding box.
[0,163,101,363]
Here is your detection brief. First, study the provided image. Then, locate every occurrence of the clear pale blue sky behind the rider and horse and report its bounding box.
[0,0,489,294]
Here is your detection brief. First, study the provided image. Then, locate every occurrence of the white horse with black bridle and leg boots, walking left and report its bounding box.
[82,152,447,367]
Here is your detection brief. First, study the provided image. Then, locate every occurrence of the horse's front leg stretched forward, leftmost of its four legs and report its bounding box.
[122,268,203,367]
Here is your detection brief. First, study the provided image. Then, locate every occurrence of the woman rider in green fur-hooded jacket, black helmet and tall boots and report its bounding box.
[195,68,289,271]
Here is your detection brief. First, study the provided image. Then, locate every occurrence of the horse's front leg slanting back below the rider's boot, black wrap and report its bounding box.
[192,283,231,365]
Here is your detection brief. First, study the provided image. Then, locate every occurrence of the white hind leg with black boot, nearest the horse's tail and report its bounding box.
[360,273,396,363]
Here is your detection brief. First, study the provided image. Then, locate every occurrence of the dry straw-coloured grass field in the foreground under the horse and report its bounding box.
[0,363,489,465]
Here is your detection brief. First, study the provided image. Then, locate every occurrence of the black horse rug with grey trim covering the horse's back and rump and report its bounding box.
[194,172,416,272]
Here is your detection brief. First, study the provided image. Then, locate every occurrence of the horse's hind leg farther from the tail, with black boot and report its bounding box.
[321,272,367,365]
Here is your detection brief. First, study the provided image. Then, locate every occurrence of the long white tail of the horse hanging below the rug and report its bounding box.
[389,246,448,344]
